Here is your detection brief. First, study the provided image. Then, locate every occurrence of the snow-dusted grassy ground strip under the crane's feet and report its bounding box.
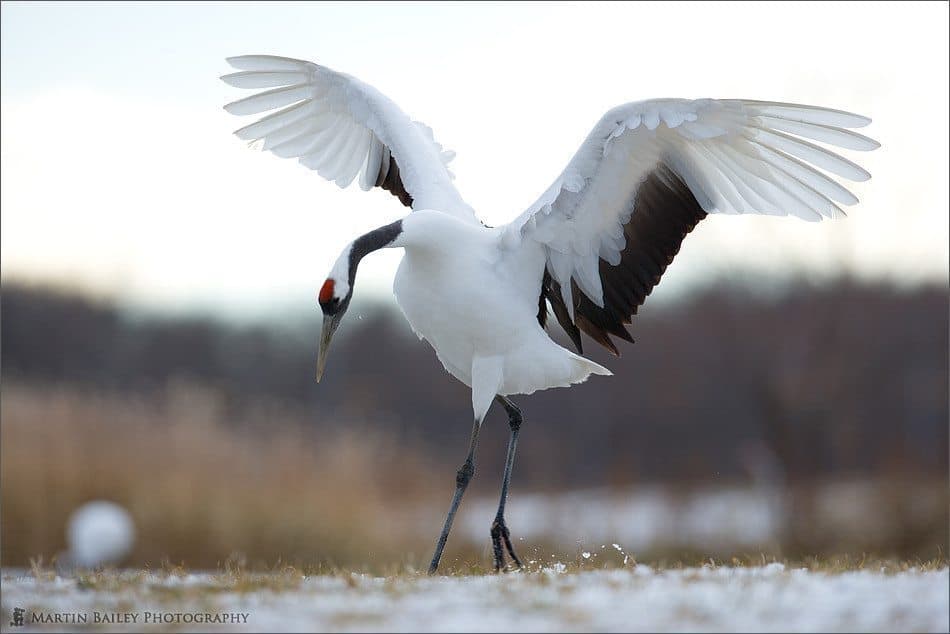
[2,563,950,632]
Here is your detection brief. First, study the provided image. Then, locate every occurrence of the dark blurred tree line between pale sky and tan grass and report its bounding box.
[0,279,948,489]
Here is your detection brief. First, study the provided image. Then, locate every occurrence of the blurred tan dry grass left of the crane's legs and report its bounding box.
[0,383,444,568]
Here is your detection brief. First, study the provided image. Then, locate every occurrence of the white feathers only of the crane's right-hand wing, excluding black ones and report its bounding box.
[504,99,879,318]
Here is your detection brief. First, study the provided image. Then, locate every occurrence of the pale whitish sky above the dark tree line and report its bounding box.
[0,2,950,318]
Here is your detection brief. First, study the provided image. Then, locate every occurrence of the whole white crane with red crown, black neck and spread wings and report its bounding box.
[222,55,879,573]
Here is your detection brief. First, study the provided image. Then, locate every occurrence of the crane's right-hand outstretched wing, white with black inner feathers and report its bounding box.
[504,99,879,354]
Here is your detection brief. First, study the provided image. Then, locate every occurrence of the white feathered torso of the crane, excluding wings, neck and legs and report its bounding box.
[393,211,610,419]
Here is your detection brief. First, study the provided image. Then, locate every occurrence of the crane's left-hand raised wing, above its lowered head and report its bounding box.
[221,55,478,223]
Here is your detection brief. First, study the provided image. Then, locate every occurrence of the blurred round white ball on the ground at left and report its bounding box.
[66,500,135,568]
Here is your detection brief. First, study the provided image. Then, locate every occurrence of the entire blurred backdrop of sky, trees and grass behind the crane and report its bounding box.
[0,2,950,569]
